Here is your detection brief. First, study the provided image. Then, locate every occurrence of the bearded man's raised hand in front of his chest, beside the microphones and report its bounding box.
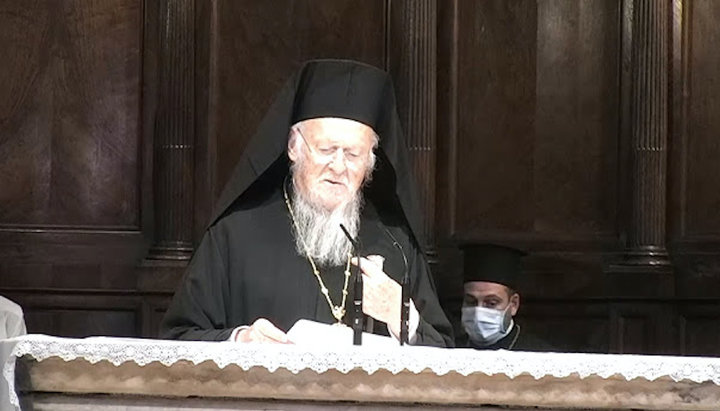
[352,257,402,336]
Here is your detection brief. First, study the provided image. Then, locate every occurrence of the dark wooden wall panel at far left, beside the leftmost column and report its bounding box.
[0,0,142,229]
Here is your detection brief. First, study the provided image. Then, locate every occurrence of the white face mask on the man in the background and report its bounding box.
[462,304,513,346]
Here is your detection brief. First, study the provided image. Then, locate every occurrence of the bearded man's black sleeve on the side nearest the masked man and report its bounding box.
[410,246,455,348]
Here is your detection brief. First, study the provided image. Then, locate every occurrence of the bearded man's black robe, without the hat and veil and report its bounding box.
[161,190,453,346]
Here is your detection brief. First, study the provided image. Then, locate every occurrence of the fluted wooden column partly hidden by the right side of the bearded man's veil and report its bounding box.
[388,0,437,252]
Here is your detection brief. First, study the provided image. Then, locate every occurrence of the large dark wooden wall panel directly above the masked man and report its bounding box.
[444,0,620,249]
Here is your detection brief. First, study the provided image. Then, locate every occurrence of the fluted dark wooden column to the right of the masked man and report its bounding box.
[624,0,670,266]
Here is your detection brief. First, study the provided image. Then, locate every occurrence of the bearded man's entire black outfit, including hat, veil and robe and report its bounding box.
[161,60,453,346]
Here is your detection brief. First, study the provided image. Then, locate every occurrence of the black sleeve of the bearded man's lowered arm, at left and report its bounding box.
[160,230,233,341]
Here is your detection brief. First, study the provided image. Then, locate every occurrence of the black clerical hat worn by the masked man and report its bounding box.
[462,244,525,290]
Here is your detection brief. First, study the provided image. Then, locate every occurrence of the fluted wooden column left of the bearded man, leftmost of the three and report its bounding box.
[148,0,195,260]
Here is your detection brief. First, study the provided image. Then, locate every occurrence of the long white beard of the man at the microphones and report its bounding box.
[292,181,363,267]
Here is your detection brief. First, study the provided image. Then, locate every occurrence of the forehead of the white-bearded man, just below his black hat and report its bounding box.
[296,117,375,146]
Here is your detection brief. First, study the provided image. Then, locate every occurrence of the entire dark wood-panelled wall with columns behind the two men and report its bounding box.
[0,0,720,355]
